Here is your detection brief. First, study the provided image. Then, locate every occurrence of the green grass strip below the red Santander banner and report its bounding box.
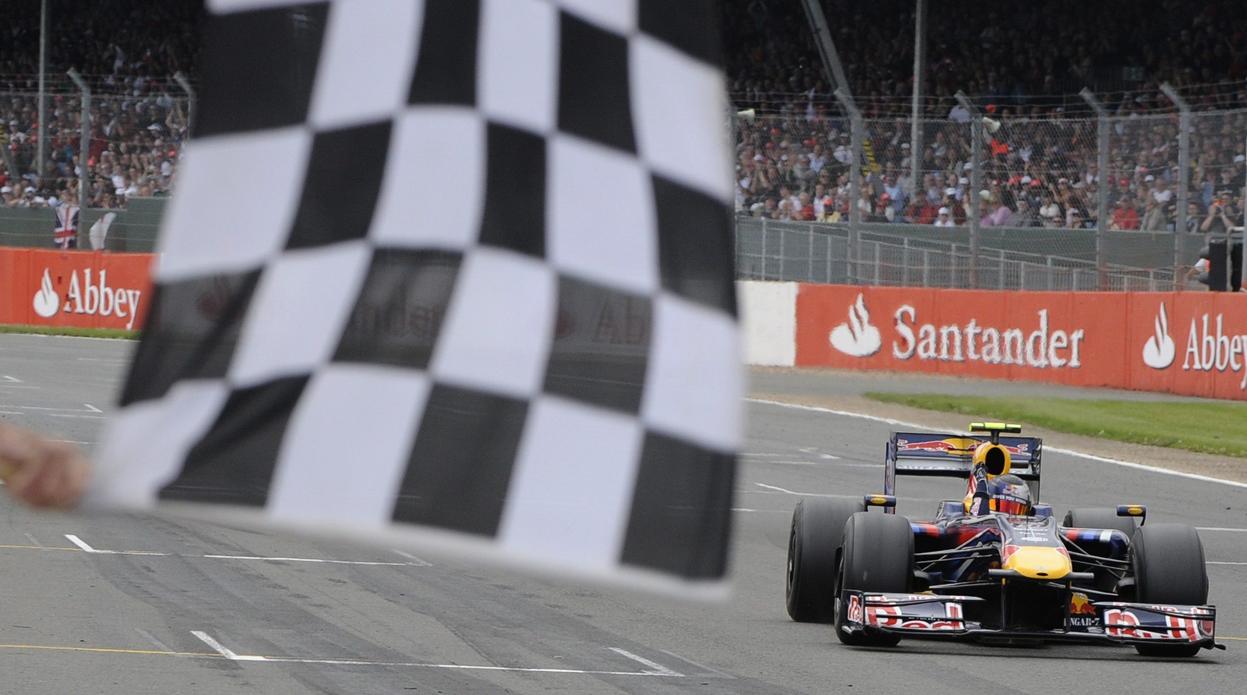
[864,392,1247,457]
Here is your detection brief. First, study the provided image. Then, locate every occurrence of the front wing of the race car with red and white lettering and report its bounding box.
[839,590,1225,649]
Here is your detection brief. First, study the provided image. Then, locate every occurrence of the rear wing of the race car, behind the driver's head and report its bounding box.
[883,432,1044,502]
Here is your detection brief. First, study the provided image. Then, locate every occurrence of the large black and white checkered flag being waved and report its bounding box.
[91,0,742,584]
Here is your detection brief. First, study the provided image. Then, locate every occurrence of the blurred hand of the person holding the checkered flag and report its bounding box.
[0,423,91,509]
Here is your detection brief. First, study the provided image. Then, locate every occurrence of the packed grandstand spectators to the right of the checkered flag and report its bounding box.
[726,0,1247,231]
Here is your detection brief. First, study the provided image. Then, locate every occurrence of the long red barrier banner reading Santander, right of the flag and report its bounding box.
[796,284,1247,399]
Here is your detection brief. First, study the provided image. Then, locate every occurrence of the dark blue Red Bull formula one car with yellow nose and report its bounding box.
[786,423,1225,656]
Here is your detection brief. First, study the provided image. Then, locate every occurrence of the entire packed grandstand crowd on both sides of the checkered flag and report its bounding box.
[0,0,1247,231]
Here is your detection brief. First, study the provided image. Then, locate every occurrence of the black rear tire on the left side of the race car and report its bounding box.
[784,499,865,623]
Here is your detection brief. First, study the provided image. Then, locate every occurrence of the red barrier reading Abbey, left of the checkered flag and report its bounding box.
[0,247,155,329]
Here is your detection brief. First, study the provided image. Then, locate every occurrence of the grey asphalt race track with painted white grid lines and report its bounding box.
[0,336,1247,695]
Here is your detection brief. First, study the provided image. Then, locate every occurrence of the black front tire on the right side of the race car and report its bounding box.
[1130,523,1208,656]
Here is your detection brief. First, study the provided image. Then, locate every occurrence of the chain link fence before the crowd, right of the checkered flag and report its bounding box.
[733,99,1247,291]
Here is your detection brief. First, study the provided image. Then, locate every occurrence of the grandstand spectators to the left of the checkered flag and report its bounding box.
[0,0,203,207]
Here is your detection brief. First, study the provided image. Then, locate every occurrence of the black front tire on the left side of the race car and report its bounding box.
[835,512,914,646]
